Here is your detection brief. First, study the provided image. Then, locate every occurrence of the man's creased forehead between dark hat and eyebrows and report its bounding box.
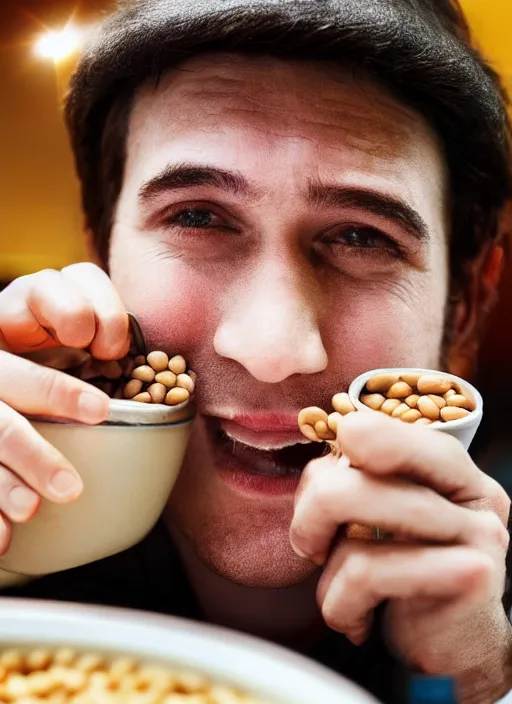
[122,54,445,210]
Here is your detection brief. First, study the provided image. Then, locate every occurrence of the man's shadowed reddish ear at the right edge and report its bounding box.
[448,243,504,379]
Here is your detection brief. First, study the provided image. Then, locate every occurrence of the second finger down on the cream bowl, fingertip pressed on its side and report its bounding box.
[0,403,83,508]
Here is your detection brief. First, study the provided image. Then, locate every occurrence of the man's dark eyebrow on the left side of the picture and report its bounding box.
[138,164,260,202]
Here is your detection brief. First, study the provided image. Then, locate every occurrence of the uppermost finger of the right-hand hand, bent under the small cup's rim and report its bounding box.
[338,412,485,503]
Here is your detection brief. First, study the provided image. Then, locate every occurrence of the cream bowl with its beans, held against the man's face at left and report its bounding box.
[0,350,196,580]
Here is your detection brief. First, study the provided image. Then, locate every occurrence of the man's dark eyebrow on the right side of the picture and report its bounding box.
[308,182,430,241]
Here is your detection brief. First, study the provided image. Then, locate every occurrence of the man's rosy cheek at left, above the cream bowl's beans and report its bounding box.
[110,238,218,358]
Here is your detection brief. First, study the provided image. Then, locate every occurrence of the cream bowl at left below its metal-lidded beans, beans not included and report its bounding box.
[0,400,193,586]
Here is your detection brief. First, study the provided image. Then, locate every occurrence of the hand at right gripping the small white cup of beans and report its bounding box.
[290,413,512,704]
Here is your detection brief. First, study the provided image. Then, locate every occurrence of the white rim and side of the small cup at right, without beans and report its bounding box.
[348,367,484,450]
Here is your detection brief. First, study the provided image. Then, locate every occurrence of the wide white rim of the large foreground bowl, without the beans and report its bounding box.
[0,599,377,704]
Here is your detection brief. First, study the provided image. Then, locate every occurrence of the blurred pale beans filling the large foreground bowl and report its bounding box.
[0,650,269,704]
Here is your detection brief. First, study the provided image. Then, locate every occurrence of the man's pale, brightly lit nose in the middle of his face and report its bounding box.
[214,261,327,384]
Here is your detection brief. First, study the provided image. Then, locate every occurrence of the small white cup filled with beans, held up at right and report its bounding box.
[348,368,483,450]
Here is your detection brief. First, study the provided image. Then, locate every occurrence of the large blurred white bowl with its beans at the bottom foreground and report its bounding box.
[0,599,377,704]
